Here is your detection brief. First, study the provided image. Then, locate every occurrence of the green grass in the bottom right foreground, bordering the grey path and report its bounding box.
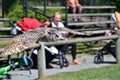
[45,65,120,80]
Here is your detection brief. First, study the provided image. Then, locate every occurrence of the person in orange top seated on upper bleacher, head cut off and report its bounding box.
[67,0,82,21]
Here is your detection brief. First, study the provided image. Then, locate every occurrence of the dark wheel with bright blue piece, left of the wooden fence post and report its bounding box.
[20,56,33,69]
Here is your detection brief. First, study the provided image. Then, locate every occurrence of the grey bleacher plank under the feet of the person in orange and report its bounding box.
[68,20,115,26]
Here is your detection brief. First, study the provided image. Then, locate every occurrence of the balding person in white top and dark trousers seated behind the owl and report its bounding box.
[50,12,81,64]
